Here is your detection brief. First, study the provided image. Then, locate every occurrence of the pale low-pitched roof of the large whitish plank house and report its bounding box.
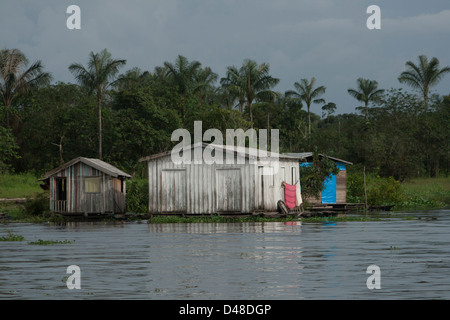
[139,143,302,162]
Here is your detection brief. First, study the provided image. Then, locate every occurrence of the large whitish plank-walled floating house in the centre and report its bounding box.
[140,143,299,214]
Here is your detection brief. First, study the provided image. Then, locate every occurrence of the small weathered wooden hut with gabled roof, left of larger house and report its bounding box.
[41,157,131,216]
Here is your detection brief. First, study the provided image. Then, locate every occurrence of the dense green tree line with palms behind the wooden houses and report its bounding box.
[0,49,450,180]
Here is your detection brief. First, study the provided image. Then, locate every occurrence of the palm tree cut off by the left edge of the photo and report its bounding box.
[0,49,51,127]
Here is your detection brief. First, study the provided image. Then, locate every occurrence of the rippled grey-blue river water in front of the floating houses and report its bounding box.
[0,210,450,300]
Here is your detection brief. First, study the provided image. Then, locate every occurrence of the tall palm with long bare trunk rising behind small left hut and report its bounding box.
[69,49,126,159]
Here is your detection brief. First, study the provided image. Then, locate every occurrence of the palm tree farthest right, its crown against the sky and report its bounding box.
[398,55,450,108]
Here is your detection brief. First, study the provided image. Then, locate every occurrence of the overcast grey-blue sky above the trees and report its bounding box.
[0,0,450,115]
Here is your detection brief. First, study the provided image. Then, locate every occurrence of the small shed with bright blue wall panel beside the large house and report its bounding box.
[287,152,353,204]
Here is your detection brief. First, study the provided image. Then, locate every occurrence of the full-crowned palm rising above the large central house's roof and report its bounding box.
[221,59,280,122]
